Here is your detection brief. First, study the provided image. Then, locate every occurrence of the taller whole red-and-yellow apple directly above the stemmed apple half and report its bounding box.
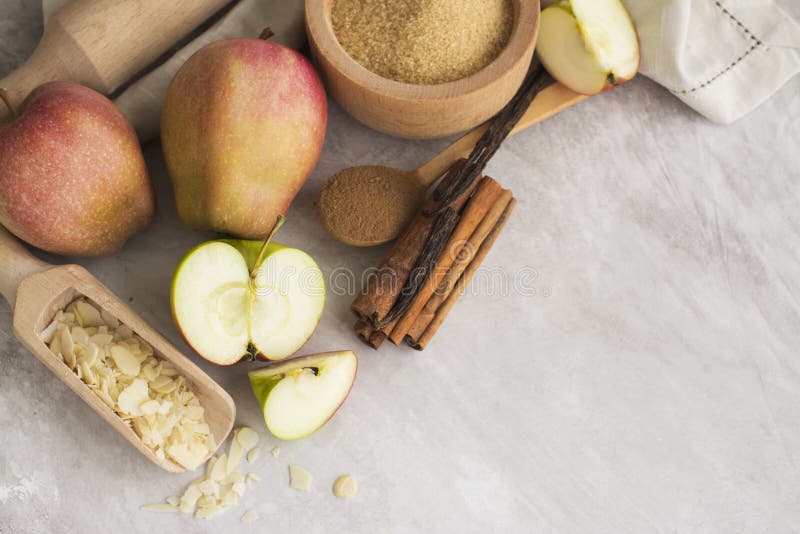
[161,39,327,239]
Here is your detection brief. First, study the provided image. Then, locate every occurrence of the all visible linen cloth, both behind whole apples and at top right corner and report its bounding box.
[43,0,800,132]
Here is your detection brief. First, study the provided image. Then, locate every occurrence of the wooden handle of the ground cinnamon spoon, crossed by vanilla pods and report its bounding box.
[415,83,588,187]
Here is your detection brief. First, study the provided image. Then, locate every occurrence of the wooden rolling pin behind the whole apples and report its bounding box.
[0,0,230,122]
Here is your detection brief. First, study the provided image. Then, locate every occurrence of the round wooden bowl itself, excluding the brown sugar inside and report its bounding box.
[306,0,540,139]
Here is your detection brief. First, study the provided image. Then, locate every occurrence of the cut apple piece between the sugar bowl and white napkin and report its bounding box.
[536,0,639,95]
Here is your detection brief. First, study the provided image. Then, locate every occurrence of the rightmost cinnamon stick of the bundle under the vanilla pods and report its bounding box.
[406,189,513,346]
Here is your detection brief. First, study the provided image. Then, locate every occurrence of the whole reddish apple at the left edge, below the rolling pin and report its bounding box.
[0,82,155,256]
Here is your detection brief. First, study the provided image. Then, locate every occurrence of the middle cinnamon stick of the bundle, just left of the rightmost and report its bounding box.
[389,176,503,344]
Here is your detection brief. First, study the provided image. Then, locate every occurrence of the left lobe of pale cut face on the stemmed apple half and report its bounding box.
[172,245,250,365]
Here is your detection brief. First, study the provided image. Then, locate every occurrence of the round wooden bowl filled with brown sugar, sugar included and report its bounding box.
[305,0,540,139]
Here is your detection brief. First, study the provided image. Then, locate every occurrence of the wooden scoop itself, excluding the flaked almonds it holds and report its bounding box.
[0,226,236,473]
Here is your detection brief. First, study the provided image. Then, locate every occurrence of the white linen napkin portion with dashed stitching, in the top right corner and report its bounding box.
[623,0,800,124]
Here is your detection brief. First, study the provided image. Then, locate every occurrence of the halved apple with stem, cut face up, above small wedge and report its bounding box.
[172,240,325,365]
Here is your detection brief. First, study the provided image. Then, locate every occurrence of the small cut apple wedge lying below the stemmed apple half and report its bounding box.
[249,350,358,440]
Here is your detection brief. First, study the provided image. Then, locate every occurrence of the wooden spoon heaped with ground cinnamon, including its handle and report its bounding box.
[317,83,588,247]
